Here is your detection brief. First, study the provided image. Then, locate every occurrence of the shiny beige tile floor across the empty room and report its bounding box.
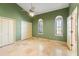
[0,37,76,56]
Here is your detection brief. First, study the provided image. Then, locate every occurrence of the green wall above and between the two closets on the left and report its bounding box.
[0,3,31,40]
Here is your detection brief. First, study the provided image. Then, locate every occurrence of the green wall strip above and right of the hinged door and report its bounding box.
[69,3,79,56]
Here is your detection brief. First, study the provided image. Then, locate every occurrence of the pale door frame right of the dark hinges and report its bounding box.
[71,7,77,55]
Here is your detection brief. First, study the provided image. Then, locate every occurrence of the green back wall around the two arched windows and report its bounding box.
[32,8,69,42]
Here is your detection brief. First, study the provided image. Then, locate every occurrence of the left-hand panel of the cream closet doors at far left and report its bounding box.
[2,18,9,46]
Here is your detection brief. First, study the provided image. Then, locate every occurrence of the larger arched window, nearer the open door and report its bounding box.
[55,16,63,36]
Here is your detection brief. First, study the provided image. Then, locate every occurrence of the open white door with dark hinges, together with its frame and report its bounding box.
[67,7,77,55]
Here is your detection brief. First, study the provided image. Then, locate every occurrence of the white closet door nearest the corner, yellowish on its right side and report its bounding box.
[21,21,32,40]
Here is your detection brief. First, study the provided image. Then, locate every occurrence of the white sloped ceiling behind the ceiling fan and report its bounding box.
[17,3,69,15]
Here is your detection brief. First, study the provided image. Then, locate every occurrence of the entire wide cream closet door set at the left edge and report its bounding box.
[0,17,16,46]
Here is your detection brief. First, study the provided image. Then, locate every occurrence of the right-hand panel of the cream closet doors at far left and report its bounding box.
[8,19,16,43]
